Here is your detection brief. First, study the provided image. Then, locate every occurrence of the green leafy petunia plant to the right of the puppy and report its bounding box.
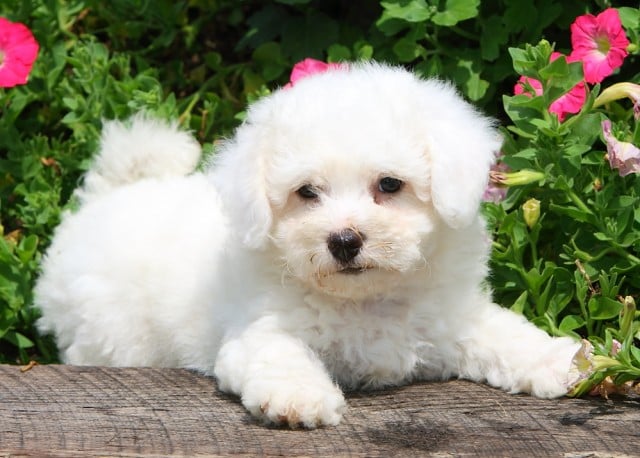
[485,24,640,394]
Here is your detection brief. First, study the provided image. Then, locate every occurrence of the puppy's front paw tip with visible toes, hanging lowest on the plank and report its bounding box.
[242,380,346,428]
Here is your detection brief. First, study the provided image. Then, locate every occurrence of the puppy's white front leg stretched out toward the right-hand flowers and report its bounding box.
[457,303,580,398]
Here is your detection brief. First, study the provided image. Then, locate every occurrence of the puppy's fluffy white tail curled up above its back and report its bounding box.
[77,114,201,201]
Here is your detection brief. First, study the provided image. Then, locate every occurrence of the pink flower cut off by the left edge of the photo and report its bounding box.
[0,17,38,87]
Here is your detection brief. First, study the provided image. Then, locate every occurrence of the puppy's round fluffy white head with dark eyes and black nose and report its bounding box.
[214,64,500,297]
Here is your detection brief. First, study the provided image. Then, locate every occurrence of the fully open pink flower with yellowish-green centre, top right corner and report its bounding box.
[570,8,629,83]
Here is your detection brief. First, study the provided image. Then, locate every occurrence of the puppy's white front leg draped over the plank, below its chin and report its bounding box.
[214,318,346,428]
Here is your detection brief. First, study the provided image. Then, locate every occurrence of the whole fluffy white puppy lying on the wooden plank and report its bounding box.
[36,64,579,427]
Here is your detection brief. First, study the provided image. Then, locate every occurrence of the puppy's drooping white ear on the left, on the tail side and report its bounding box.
[211,124,272,249]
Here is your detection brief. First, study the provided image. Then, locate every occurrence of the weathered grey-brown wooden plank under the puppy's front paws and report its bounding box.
[0,365,640,457]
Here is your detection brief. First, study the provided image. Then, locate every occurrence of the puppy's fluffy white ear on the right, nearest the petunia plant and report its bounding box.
[422,80,502,229]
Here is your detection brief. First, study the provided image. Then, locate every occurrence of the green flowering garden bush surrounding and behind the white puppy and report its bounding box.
[0,0,640,394]
